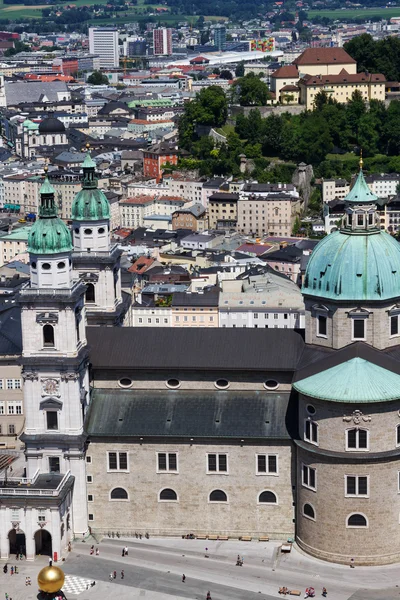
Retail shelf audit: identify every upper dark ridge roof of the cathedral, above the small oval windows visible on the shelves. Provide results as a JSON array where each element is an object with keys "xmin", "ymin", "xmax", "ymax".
[{"xmin": 86, "ymin": 327, "xmax": 304, "ymax": 371}]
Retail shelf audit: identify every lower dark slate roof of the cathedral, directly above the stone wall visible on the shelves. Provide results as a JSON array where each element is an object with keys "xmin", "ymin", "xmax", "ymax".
[{"xmin": 85, "ymin": 389, "xmax": 289, "ymax": 439}]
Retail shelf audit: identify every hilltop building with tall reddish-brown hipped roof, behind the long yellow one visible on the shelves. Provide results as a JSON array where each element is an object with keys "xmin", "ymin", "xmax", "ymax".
[{"xmin": 293, "ymin": 48, "xmax": 357, "ymax": 77}]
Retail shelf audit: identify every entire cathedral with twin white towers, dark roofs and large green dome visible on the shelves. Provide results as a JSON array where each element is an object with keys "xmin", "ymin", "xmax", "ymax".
[{"xmin": 0, "ymin": 154, "xmax": 400, "ymax": 565}]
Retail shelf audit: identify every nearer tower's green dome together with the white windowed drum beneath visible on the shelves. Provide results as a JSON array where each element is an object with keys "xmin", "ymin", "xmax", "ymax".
[{"xmin": 28, "ymin": 172, "xmax": 72, "ymax": 287}]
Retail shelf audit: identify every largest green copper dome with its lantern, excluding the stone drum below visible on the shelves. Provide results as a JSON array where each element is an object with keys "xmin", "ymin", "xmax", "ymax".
[{"xmin": 302, "ymin": 163, "xmax": 400, "ymax": 301}]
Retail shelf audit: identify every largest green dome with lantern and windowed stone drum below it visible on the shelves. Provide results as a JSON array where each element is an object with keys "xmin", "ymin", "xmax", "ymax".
[{"xmin": 302, "ymin": 159, "xmax": 400, "ymax": 348}]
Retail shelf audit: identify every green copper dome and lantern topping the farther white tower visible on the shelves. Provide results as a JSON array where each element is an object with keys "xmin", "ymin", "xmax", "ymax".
[{"xmin": 72, "ymin": 152, "xmax": 110, "ymax": 221}]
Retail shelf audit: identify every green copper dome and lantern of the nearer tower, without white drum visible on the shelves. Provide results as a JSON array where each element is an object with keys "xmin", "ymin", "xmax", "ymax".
[{"xmin": 28, "ymin": 176, "xmax": 72, "ymax": 254}]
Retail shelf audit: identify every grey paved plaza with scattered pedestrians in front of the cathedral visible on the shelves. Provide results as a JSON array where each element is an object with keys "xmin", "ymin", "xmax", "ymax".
[{"xmin": 0, "ymin": 537, "xmax": 400, "ymax": 600}]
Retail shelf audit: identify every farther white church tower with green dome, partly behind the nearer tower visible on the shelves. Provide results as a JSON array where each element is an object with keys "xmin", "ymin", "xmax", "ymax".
[{"xmin": 72, "ymin": 152, "xmax": 124, "ymax": 326}]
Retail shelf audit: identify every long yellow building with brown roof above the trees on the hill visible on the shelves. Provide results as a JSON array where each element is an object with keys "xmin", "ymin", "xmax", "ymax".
[{"xmin": 298, "ymin": 70, "xmax": 385, "ymax": 110}]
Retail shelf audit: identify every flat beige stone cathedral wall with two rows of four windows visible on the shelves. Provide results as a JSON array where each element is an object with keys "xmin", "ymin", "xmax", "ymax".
[{"xmin": 87, "ymin": 440, "xmax": 295, "ymax": 539}]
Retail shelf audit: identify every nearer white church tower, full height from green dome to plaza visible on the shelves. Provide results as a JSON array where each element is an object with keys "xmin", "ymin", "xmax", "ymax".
[{"xmin": 15, "ymin": 171, "xmax": 89, "ymax": 560}]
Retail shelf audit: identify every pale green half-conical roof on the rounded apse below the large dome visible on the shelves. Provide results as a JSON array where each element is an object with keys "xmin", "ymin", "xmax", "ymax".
[{"xmin": 293, "ymin": 356, "xmax": 400, "ymax": 403}]
